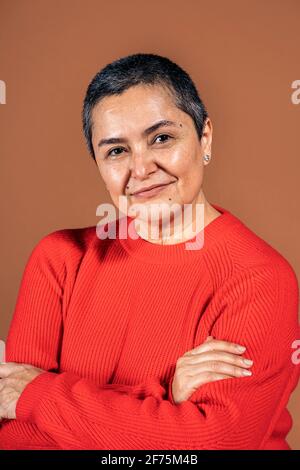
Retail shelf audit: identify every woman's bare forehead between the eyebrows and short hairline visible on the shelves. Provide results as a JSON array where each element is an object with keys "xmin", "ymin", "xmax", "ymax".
[{"xmin": 92, "ymin": 85, "xmax": 186, "ymax": 137}]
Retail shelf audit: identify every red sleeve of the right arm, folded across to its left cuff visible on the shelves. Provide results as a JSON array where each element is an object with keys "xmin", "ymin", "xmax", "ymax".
[{"xmin": 12, "ymin": 262, "xmax": 299, "ymax": 450}]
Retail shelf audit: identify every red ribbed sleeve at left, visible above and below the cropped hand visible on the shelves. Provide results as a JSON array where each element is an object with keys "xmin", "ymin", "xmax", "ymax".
[{"xmin": 0, "ymin": 229, "xmax": 80, "ymax": 449}]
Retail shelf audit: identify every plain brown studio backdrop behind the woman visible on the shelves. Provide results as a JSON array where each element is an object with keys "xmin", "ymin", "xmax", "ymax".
[{"xmin": 0, "ymin": 0, "xmax": 300, "ymax": 449}]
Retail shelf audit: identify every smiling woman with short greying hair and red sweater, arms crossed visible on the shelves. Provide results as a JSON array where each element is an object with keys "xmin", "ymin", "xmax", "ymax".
[{"xmin": 0, "ymin": 54, "xmax": 299, "ymax": 449}]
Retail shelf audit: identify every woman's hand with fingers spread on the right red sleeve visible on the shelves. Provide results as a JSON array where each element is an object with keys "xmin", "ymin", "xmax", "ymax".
[{"xmin": 172, "ymin": 336, "xmax": 253, "ymax": 404}]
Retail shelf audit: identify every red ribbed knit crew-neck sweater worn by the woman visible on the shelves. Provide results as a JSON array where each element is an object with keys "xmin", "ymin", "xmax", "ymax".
[{"xmin": 0, "ymin": 204, "xmax": 300, "ymax": 450}]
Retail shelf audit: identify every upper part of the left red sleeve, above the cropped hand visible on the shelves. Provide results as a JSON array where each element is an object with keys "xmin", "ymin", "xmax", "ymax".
[{"xmin": 6, "ymin": 231, "xmax": 66, "ymax": 370}]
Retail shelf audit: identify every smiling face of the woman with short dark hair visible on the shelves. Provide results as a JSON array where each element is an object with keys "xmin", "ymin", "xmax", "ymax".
[{"xmin": 92, "ymin": 85, "xmax": 212, "ymax": 222}]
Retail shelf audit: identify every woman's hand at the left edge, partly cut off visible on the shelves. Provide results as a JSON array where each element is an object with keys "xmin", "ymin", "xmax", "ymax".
[{"xmin": 0, "ymin": 362, "xmax": 45, "ymax": 419}]
